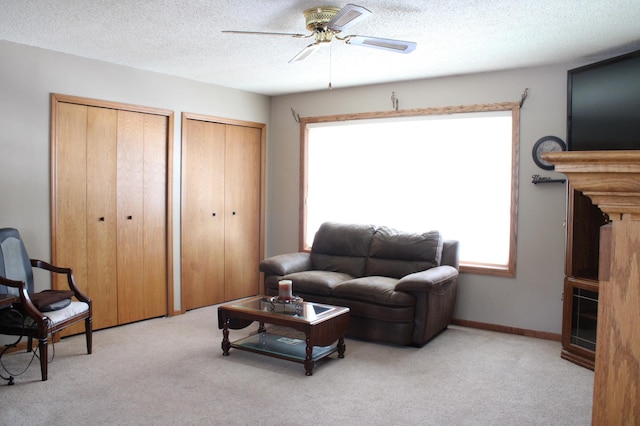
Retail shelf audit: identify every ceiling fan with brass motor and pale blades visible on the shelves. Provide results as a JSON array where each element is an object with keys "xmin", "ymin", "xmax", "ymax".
[{"xmin": 222, "ymin": 4, "xmax": 417, "ymax": 63}]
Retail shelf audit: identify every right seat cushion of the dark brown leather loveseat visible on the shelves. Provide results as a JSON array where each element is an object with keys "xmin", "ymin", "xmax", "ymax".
[{"xmin": 333, "ymin": 276, "xmax": 416, "ymax": 307}]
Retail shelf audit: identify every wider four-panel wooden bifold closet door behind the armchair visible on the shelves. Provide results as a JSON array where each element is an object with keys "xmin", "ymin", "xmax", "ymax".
[{"xmin": 52, "ymin": 95, "xmax": 172, "ymax": 329}]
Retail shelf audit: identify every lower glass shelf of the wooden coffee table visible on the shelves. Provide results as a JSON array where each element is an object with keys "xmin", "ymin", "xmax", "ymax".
[{"xmin": 231, "ymin": 332, "xmax": 338, "ymax": 362}]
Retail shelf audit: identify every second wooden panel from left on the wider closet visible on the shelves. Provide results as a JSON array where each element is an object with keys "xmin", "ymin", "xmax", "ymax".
[{"xmin": 81, "ymin": 107, "xmax": 118, "ymax": 329}]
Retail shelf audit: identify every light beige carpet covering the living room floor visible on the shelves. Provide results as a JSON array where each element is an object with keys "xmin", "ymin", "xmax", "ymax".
[{"xmin": 0, "ymin": 306, "xmax": 593, "ymax": 426}]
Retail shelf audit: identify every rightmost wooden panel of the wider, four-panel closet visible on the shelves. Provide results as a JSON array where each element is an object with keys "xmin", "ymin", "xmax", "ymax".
[{"xmin": 143, "ymin": 114, "xmax": 168, "ymax": 318}]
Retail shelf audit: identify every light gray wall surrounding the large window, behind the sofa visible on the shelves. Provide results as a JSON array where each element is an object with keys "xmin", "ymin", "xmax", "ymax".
[{"xmin": 266, "ymin": 66, "xmax": 584, "ymax": 333}]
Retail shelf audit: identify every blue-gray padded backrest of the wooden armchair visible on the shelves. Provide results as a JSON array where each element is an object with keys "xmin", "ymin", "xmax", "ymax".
[{"xmin": 0, "ymin": 228, "xmax": 34, "ymax": 296}]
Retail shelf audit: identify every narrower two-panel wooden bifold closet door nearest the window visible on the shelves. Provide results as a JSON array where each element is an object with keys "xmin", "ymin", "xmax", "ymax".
[{"xmin": 181, "ymin": 114, "xmax": 265, "ymax": 310}]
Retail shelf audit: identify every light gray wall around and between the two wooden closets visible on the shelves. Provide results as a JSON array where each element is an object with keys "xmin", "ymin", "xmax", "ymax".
[{"xmin": 0, "ymin": 40, "xmax": 271, "ymax": 310}]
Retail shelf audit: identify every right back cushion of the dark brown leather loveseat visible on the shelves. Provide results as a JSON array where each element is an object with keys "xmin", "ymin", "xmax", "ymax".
[{"xmin": 365, "ymin": 226, "xmax": 443, "ymax": 278}]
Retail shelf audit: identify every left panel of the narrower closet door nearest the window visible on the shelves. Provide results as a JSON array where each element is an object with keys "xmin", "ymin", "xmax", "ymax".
[{"xmin": 182, "ymin": 119, "xmax": 225, "ymax": 310}]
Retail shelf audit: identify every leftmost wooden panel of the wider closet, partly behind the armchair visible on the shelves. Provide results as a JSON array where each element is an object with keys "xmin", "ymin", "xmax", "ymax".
[{"xmin": 52, "ymin": 103, "xmax": 89, "ymax": 290}]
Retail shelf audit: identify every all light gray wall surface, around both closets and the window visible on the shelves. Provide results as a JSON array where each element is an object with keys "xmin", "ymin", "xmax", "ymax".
[{"xmin": 0, "ymin": 37, "xmax": 584, "ymax": 333}]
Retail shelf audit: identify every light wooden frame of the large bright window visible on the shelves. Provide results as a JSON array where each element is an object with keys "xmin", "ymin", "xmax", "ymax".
[{"xmin": 299, "ymin": 102, "xmax": 520, "ymax": 277}]
